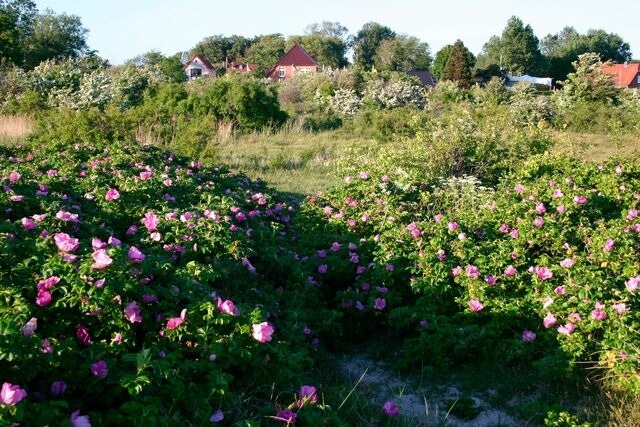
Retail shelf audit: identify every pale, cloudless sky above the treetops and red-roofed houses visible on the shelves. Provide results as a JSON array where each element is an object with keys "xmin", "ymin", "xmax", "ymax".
[{"xmin": 35, "ymin": 0, "xmax": 640, "ymax": 65}]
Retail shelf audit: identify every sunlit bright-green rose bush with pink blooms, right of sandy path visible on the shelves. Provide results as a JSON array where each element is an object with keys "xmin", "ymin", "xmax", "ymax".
[{"xmin": 303, "ymin": 155, "xmax": 640, "ymax": 392}]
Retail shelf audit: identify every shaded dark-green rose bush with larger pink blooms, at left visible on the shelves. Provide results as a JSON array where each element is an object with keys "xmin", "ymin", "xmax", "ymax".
[{"xmin": 0, "ymin": 135, "xmax": 335, "ymax": 426}]
